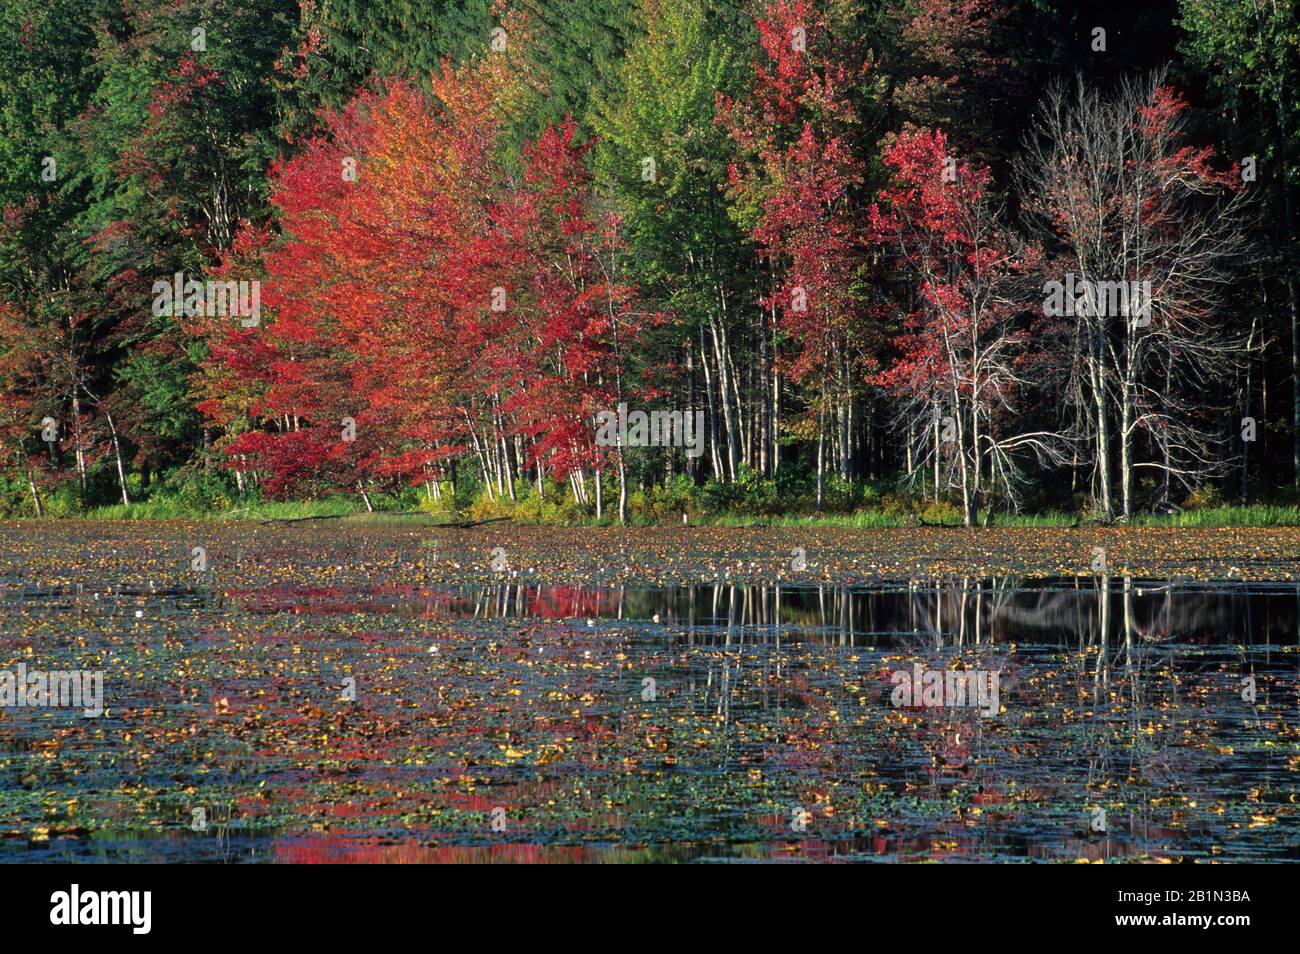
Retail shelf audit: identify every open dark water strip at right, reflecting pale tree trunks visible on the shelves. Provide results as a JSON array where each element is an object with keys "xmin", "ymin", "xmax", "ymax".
[{"xmin": 343, "ymin": 577, "xmax": 1300, "ymax": 646}]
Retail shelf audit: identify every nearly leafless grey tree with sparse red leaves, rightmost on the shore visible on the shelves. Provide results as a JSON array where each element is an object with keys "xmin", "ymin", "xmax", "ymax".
[{"xmin": 1018, "ymin": 73, "xmax": 1248, "ymax": 517}]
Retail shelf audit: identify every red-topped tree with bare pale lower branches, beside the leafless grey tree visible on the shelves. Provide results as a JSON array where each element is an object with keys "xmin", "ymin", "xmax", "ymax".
[{"xmin": 874, "ymin": 131, "xmax": 1065, "ymax": 526}]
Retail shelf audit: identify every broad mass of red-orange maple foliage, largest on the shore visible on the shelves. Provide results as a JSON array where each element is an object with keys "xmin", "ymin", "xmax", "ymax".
[{"xmin": 202, "ymin": 73, "xmax": 646, "ymax": 494}]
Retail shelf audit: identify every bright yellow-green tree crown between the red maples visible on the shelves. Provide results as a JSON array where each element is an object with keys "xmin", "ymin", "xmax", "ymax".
[{"xmin": 592, "ymin": 0, "xmax": 755, "ymax": 376}]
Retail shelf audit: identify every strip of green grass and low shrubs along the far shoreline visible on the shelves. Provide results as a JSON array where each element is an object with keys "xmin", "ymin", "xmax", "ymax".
[{"xmin": 10, "ymin": 468, "xmax": 1300, "ymax": 529}]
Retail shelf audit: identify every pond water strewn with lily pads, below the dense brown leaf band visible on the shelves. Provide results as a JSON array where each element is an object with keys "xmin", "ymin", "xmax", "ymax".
[{"xmin": 0, "ymin": 577, "xmax": 1300, "ymax": 862}]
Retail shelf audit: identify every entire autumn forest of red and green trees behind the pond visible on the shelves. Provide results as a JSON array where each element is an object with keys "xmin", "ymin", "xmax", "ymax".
[{"xmin": 0, "ymin": 0, "xmax": 1300, "ymax": 525}]
